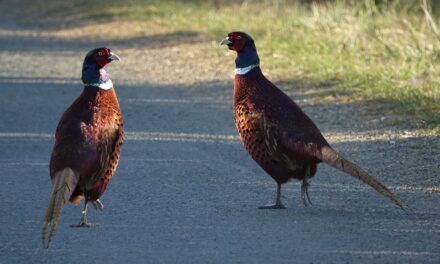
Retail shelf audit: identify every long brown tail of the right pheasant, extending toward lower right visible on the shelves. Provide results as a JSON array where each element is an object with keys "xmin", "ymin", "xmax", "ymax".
[{"xmin": 320, "ymin": 147, "xmax": 414, "ymax": 215}]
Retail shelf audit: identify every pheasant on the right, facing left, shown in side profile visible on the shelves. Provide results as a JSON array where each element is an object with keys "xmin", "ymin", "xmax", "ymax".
[{"xmin": 220, "ymin": 32, "xmax": 412, "ymax": 213}]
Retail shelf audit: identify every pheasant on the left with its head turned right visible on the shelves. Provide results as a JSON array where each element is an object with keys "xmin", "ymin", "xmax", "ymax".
[{"xmin": 42, "ymin": 48, "xmax": 124, "ymax": 248}]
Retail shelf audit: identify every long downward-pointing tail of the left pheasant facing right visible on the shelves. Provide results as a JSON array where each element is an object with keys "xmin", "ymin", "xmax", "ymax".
[{"xmin": 41, "ymin": 168, "xmax": 78, "ymax": 248}]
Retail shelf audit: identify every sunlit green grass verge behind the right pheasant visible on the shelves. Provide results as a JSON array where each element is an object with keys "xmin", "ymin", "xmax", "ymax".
[{"xmin": 31, "ymin": 0, "xmax": 440, "ymax": 134}]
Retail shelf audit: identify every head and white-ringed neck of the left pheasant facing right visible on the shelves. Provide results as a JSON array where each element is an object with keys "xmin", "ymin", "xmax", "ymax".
[{"xmin": 81, "ymin": 48, "xmax": 120, "ymax": 89}]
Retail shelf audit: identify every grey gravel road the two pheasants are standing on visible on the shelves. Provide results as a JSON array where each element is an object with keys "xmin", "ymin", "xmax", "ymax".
[{"xmin": 0, "ymin": 9, "xmax": 440, "ymax": 264}]
